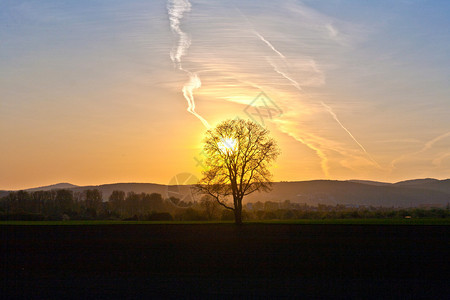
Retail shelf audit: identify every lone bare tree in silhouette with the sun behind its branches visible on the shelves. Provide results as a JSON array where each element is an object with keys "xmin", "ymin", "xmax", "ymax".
[{"xmin": 197, "ymin": 120, "xmax": 280, "ymax": 224}]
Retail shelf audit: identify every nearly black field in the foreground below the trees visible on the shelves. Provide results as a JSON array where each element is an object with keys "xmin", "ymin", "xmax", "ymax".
[{"xmin": 0, "ymin": 224, "xmax": 450, "ymax": 299}]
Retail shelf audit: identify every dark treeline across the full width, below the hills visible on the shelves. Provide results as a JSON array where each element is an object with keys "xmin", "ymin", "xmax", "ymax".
[{"xmin": 0, "ymin": 189, "xmax": 450, "ymax": 221}]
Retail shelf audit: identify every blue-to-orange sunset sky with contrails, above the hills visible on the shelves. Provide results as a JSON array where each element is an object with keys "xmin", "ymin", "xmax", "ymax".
[{"xmin": 0, "ymin": 0, "xmax": 450, "ymax": 189}]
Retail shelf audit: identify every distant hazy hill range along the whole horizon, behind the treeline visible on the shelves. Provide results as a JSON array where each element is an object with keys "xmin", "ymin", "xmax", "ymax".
[{"xmin": 0, "ymin": 178, "xmax": 450, "ymax": 207}]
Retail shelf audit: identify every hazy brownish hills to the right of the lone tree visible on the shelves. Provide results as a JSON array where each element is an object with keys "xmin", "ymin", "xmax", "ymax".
[{"xmin": 247, "ymin": 180, "xmax": 450, "ymax": 207}]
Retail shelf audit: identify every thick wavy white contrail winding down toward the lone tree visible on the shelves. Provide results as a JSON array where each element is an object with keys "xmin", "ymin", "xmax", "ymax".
[{"xmin": 167, "ymin": 0, "xmax": 210, "ymax": 128}]
